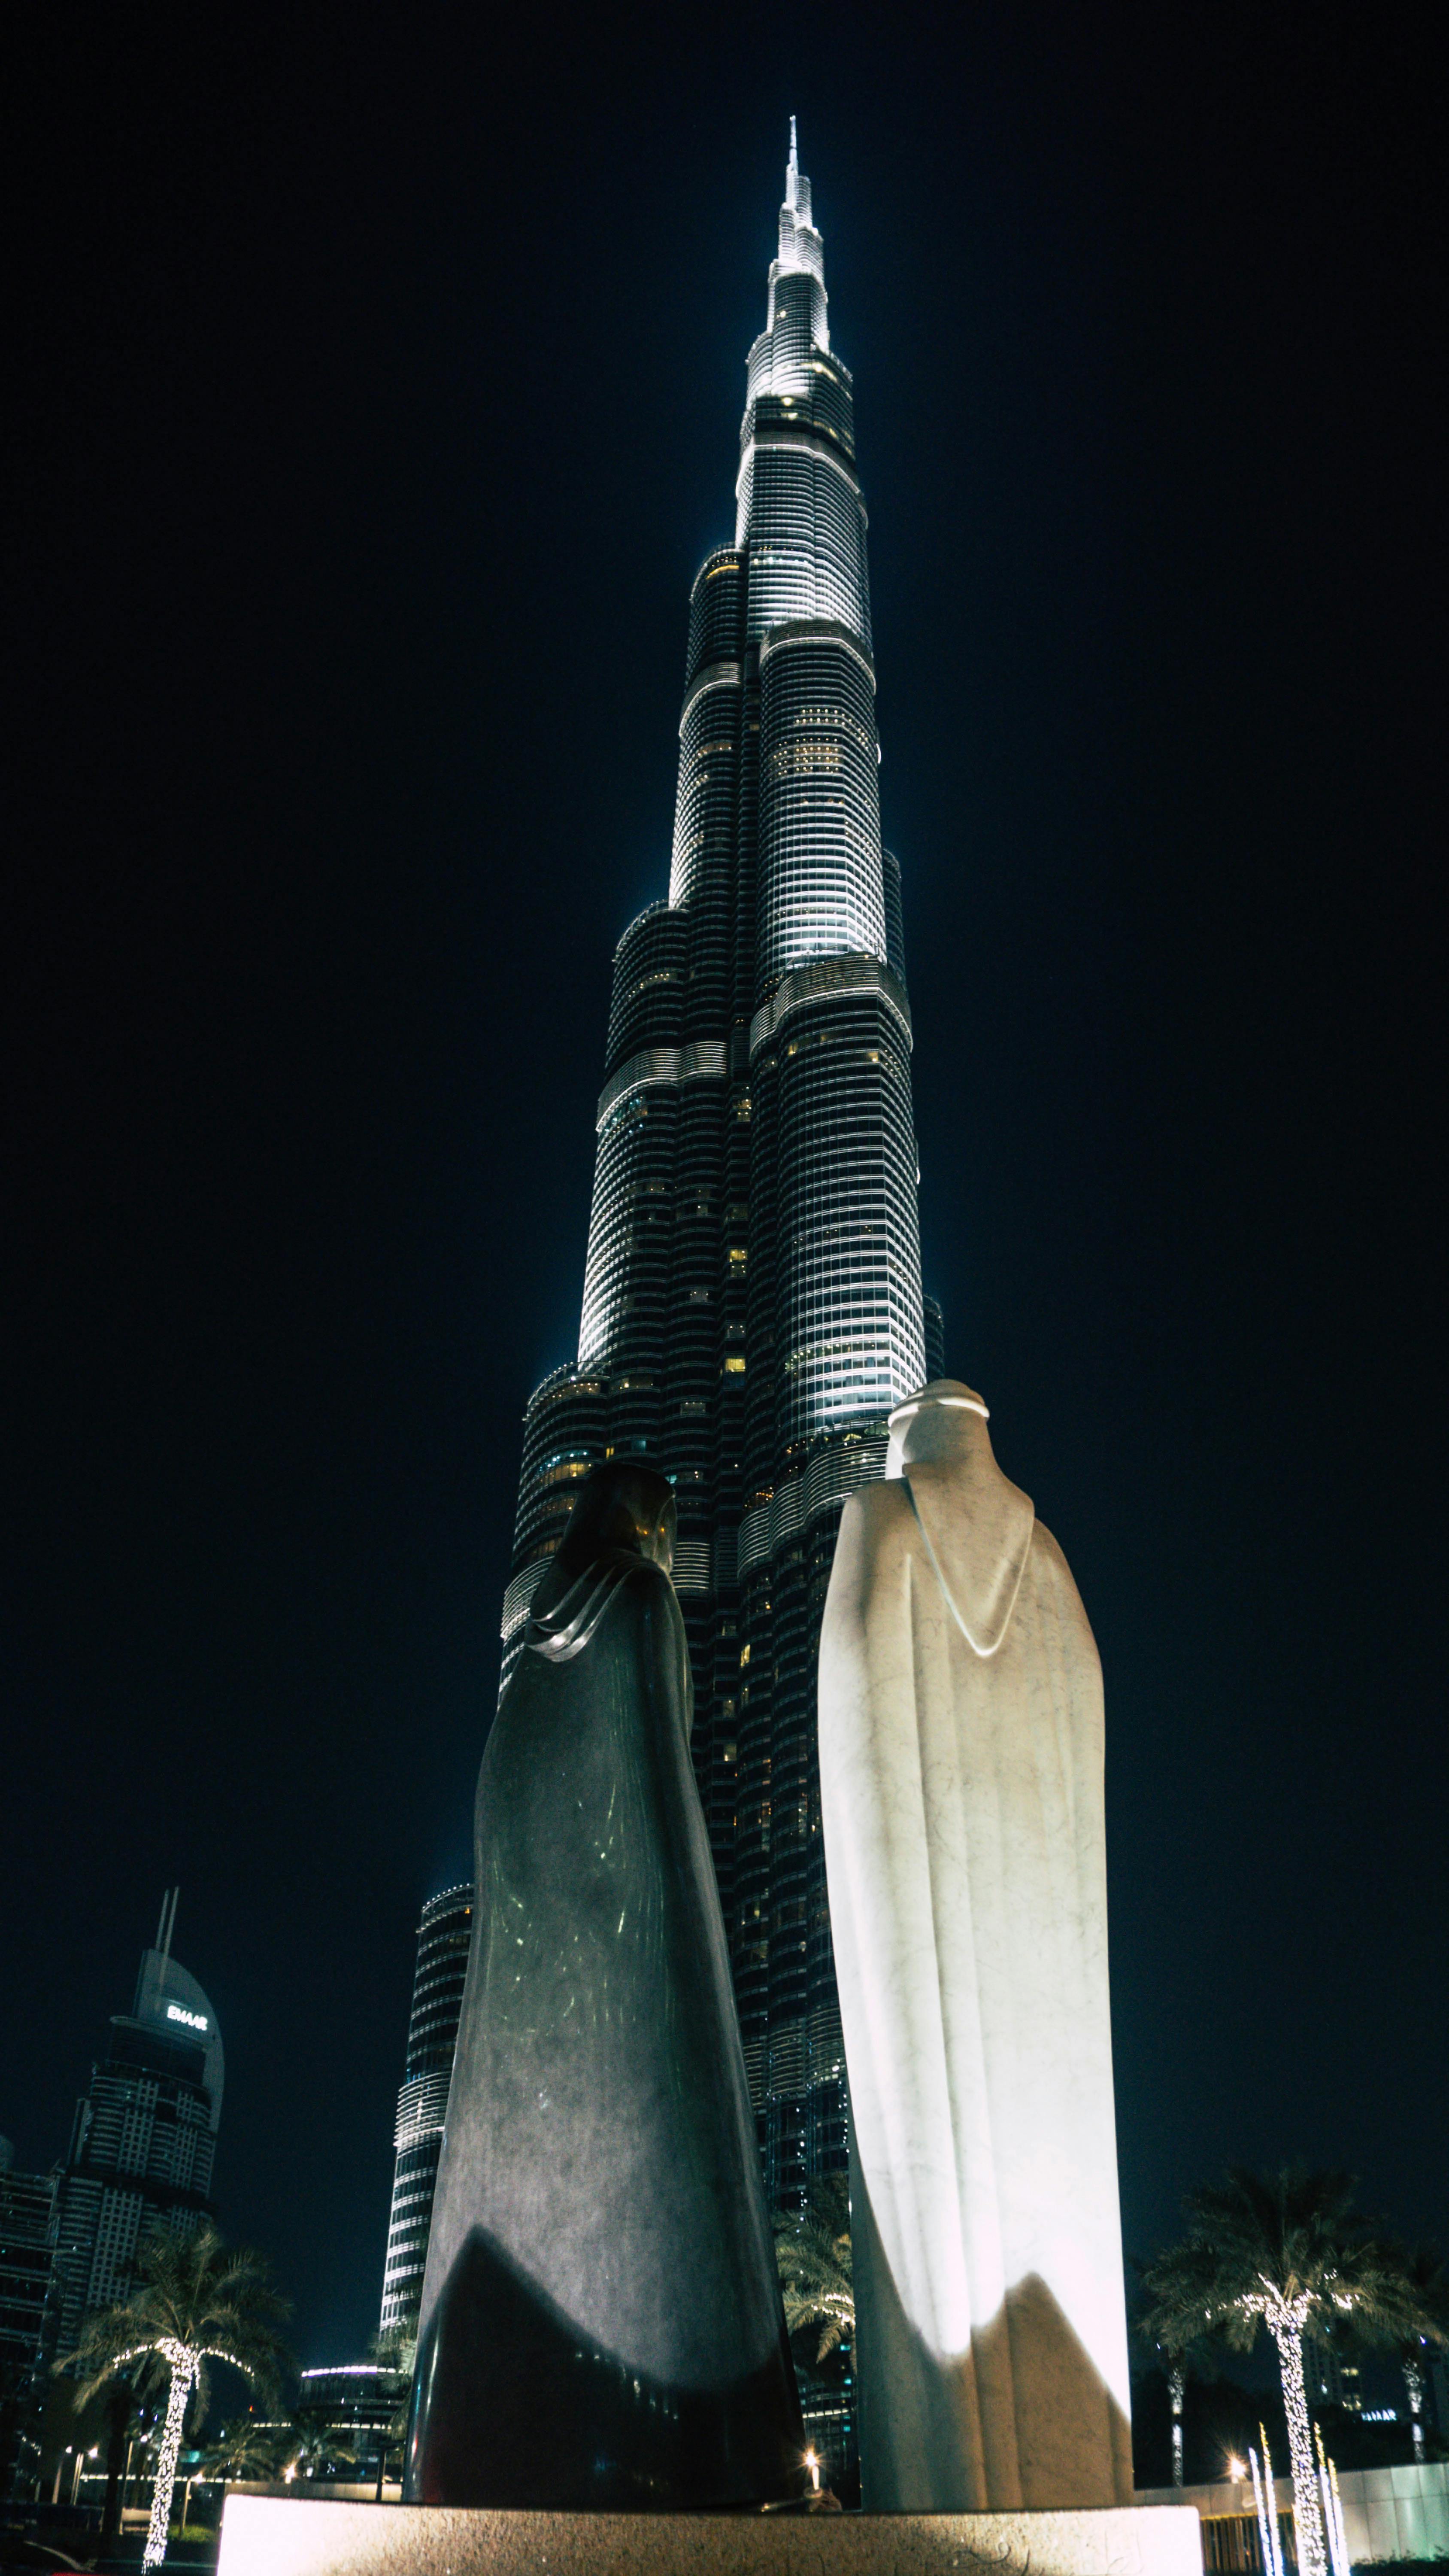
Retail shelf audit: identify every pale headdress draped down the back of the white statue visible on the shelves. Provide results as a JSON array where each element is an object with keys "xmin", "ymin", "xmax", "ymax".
[{"xmin": 901, "ymin": 1406, "xmax": 1037, "ymax": 1656}]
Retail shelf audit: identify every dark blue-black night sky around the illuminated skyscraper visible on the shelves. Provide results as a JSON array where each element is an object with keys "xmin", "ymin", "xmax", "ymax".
[{"xmin": 0, "ymin": 5, "xmax": 1449, "ymax": 2362}]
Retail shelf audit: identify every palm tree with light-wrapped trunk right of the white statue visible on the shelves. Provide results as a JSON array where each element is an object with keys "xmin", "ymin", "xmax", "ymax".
[{"xmin": 1143, "ymin": 2164, "xmax": 1441, "ymax": 2576}]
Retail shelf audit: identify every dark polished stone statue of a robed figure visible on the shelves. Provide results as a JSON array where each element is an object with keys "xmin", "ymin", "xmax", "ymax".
[{"xmin": 404, "ymin": 1461, "xmax": 806, "ymax": 2512}]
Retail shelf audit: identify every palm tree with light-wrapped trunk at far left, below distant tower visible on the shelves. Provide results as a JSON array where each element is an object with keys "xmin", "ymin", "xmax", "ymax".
[{"xmin": 57, "ymin": 2221, "xmax": 286, "ymax": 2568}]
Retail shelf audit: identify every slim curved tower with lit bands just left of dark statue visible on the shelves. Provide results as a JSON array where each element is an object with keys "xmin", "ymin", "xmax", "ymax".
[{"xmin": 378, "ymin": 1886, "xmax": 473, "ymax": 2334}]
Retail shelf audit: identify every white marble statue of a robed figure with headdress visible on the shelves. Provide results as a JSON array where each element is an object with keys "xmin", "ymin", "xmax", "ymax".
[{"xmin": 821, "ymin": 1378, "xmax": 1132, "ymax": 2512}]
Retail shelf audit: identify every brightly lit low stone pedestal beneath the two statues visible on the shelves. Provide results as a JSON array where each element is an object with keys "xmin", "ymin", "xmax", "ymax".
[{"xmin": 219, "ymin": 2496, "xmax": 1202, "ymax": 2576}]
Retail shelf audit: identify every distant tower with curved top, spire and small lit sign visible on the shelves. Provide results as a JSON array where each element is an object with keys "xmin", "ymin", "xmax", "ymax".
[{"xmin": 57, "ymin": 1888, "xmax": 227, "ymax": 2352}]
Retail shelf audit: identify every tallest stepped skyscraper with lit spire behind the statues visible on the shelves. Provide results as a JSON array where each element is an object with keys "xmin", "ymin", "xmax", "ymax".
[{"xmin": 502, "ymin": 129, "xmax": 942, "ymax": 2202}]
